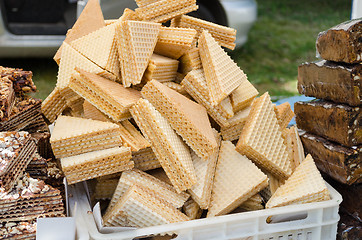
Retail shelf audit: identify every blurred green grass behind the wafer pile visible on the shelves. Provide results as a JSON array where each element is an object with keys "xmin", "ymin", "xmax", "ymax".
[{"xmin": 0, "ymin": 0, "xmax": 352, "ymax": 100}]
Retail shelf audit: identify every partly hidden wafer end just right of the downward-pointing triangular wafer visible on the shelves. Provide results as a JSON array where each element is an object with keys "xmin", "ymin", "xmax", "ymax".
[{"xmin": 142, "ymin": 53, "xmax": 178, "ymax": 82}]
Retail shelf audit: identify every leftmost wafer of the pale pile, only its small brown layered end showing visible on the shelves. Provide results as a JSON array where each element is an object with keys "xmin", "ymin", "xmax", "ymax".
[{"xmin": 41, "ymin": 87, "xmax": 67, "ymax": 123}]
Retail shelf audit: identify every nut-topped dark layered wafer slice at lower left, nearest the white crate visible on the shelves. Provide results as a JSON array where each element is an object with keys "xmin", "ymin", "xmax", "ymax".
[{"xmin": 0, "ymin": 173, "xmax": 65, "ymax": 222}]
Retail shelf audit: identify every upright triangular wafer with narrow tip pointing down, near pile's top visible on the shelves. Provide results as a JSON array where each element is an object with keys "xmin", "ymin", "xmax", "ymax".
[{"xmin": 116, "ymin": 20, "xmax": 161, "ymax": 87}]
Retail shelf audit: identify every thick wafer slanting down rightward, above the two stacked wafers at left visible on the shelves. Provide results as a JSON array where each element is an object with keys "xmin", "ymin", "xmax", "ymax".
[{"xmin": 69, "ymin": 69, "xmax": 141, "ymax": 122}]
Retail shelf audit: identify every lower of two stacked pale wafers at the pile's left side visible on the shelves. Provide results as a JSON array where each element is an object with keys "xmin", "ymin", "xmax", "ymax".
[{"xmin": 60, "ymin": 147, "xmax": 134, "ymax": 184}]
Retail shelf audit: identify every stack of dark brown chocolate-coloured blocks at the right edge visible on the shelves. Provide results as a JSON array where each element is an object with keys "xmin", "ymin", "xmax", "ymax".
[{"xmin": 294, "ymin": 19, "xmax": 362, "ymax": 239}]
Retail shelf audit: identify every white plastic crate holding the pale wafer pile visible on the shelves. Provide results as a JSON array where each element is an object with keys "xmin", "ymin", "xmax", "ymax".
[{"xmin": 68, "ymin": 183, "xmax": 342, "ymax": 240}]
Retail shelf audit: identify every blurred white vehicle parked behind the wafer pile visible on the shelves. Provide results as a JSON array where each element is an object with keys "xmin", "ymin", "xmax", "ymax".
[{"xmin": 0, "ymin": 0, "xmax": 257, "ymax": 58}]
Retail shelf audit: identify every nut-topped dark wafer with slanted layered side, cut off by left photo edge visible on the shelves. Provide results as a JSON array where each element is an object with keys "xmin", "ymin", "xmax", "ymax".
[{"xmin": 0, "ymin": 131, "xmax": 36, "ymax": 192}]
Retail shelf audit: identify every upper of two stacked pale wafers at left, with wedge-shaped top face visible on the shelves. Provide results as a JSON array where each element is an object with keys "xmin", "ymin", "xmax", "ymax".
[{"xmin": 50, "ymin": 116, "xmax": 122, "ymax": 158}]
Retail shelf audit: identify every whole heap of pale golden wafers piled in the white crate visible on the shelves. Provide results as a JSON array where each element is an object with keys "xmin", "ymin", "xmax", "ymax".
[{"xmin": 42, "ymin": 0, "xmax": 329, "ymax": 230}]
